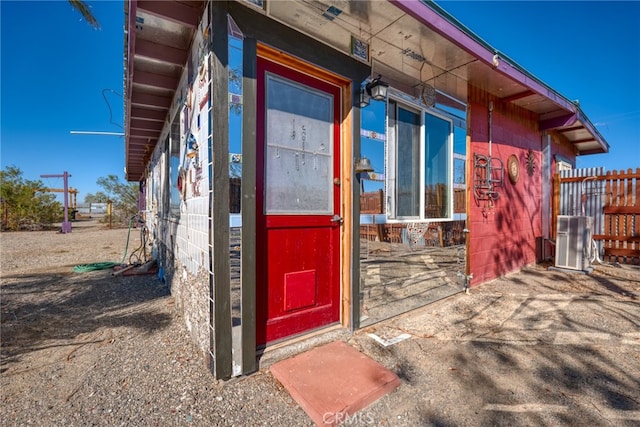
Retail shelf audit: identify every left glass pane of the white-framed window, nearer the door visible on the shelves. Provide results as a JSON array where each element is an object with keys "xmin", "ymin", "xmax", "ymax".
[{"xmin": 396, "ymin": 107, "xmax": 420, "ymax": 217}]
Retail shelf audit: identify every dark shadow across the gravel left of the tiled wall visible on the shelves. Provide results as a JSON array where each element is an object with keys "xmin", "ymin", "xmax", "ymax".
[{"xmin": 0, "ymin": 270, "xmax": 171, "ymax": 372}]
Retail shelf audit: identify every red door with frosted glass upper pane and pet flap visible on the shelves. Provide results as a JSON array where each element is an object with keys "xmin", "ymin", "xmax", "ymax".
[{"xmin": 256, "ymin": 58, "xmax": 341, "ymax": 345}]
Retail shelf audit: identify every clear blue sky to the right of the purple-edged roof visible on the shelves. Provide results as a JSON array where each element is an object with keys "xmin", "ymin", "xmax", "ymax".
[{"xmin": 437, "ymin": 1, "xmax": 640, "ymax": 170}]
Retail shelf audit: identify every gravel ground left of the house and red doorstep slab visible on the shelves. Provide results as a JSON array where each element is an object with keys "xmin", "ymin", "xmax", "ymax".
[{"xmin": 0, "ymin": 221, "xmax": 310, "ymax": 426}]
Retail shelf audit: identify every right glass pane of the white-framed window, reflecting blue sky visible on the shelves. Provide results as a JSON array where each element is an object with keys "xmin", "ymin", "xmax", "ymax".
[{"xmin": 424, "ymin": 114, "xmax": 451, "ymax": 218}]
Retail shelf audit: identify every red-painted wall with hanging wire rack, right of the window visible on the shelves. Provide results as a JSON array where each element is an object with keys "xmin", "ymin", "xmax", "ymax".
[{"xmin": 468, "ymin": 102, "xmax": 546, "ymax": 285}]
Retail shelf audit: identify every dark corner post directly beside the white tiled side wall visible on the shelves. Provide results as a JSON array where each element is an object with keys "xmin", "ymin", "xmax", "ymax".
[{"xmin": 209, "ymin": 1, "xmax": 232, "ymax": 379}]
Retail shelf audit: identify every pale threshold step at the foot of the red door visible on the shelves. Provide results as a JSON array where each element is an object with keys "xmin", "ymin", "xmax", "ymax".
[{"xmin": 256, "ymin": 323, "xmax": 351, "ymax": 369}]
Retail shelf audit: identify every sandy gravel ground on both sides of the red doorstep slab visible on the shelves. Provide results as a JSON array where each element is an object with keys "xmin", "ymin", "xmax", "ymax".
[{"xmin": 0, "ymin": 221, "xmax": 640, "ymax": 426}]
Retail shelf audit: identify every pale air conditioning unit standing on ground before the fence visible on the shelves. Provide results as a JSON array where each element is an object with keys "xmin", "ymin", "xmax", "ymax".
[{"xmin": 556, "ymin": 215, "xmax": 593, "ymax": 270}]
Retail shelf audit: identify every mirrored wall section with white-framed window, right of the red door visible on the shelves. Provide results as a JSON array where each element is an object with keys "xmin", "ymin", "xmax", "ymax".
[{"xmin": 359, "ymin": 88, "xmax": 466, "ymax": 327}]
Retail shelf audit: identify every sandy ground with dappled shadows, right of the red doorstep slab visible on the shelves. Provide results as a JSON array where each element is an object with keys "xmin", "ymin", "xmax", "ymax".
[{"xmin": 360, "ymin": 267, "xmax": 640, "ymax": 426}]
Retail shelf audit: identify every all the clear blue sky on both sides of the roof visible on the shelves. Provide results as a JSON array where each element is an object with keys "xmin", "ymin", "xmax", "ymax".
[{"xmin": 0, "ymin": 0, "xmax": 640, "ymax": 201}]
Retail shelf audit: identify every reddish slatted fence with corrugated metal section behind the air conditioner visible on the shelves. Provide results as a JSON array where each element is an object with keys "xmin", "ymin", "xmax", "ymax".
[{"xmin": 552, "ymin": 168, "xmax": 640, "ymax": 264}]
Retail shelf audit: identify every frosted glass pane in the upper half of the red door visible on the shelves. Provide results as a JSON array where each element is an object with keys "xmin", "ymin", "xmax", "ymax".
[{"xmin": 265, "ymin": 75, "xmax": 333, "ymax": 215}]
